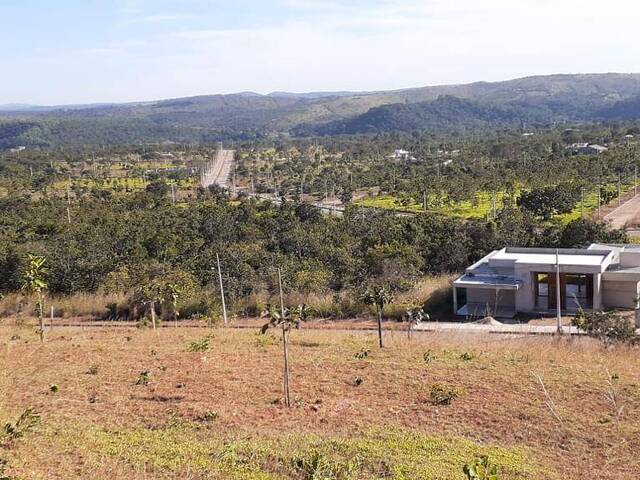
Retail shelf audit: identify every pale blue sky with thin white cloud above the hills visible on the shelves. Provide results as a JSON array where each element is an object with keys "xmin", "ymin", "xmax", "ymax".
[{"xmin": 0, "ymin": 0, "xmax": 640, "ymax": 105}]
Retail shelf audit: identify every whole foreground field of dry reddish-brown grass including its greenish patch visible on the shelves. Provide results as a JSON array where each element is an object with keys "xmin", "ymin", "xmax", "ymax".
[{"xmin": 0, "ymin": 323, "xmax": 640, "ymax": 480}]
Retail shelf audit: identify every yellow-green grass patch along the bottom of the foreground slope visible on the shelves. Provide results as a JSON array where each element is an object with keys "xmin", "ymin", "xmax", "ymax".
[{"xmin": 51, "ymin": 423, "xmax": 550, "ymax": 480}]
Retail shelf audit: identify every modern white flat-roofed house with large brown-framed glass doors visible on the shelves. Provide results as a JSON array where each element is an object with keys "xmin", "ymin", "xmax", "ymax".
[{"xmin": 453, "ymin": 244, "xmax": 640, "ymax": 318}]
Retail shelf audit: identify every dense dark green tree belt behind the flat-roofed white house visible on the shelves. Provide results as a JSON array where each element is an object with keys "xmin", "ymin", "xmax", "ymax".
[{"xmin": 0, "ymin": 188, "xmax": 624, "ymax": 298}]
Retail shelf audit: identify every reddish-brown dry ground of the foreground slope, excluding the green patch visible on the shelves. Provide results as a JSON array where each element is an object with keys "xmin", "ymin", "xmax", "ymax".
[{"xmin": 0, "ymin": 324, "xmax": 640, "ymax": 479}]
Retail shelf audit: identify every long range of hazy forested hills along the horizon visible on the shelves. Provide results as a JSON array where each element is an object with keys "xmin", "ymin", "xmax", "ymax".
[{"xmin": 0, "ymin": 73, "xmax": 640, "ymax": 148}]
